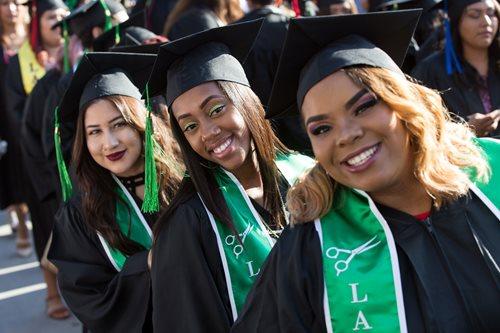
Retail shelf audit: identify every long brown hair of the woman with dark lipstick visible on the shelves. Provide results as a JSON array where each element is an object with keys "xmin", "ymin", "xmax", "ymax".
[{"xmin": 72, "ymin": 95, "xmax": 183, "ymax": 255}]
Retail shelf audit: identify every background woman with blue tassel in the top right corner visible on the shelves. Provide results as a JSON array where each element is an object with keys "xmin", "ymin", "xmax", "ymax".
[{"xmin": 412, "ymin": 0, "xmax": 500, "ymax": 136}]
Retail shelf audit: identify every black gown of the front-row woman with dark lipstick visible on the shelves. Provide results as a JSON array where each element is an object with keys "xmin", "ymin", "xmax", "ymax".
[{"xmin": 48, "ymin": 192, "xmax": 152, "ymax": 333}]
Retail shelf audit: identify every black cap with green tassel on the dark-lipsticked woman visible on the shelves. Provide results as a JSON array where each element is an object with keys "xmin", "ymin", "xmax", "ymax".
[{"xmin": 54, "ymin": 52, "xmax": 158, "ymax": 208}]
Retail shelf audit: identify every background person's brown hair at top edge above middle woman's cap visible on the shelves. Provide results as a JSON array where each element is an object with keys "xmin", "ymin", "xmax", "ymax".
[{"xmin": 163, "ymin": 0, "xmax": 243, "ymax": 37}]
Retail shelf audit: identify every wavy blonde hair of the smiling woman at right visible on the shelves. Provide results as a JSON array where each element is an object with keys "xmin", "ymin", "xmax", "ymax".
[{"xmin": 287, "ymin": 67, "xmax": 489, "ymax": 223}]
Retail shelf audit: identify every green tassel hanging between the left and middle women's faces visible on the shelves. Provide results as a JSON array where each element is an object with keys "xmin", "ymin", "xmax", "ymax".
[{"xmin": 141, "ymin": 84, "xmax": 160, "ymax": 213}]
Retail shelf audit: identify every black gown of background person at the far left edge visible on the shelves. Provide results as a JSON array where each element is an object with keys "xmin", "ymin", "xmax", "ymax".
[{"xmin": 4, "ymin": 55, "xmax": 29, "ymax": 204}]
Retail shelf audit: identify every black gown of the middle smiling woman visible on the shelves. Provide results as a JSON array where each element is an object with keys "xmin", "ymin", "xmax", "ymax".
[{"xmin": 151, "ymin": 179, "xmax": 288, "ymax": 333}]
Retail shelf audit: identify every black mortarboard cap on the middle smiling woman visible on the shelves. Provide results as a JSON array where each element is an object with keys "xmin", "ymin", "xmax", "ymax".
[{"xmin": 148, "ymin": 19, "xmax": 263, "ymax": 106}]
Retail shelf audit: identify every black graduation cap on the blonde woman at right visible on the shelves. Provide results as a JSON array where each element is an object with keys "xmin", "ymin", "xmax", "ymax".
[{"xmin": 266, "ymin": 9, "xmax": 421, "ymax": 118}]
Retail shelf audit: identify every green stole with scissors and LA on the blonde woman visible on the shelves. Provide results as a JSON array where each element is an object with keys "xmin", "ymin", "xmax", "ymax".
[{"xmin": 314, "ymin": 139, "xmax": 500, "ymax": 333}]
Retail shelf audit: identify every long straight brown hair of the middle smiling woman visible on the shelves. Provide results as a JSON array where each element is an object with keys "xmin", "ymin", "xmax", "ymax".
[{"xmin": 156, "ymin": 81, "xmax": 288, "ymax": 234}]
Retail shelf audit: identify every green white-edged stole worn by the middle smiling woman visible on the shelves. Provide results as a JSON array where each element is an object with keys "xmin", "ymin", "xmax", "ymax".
[{"xmin": 200, "ymin": 154, "xmax": 314, "ymax": 320}]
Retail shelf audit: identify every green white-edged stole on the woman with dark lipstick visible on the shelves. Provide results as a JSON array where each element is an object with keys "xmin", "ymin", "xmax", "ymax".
[{"xmin": 97, "ymin": 175, "xmax": 153, "ymax": 271}]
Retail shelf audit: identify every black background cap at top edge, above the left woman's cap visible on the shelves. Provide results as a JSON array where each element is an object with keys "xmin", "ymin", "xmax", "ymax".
[{"xmin": 54, "ymin": 0, "xmax": 126, "ymax": 37}]
